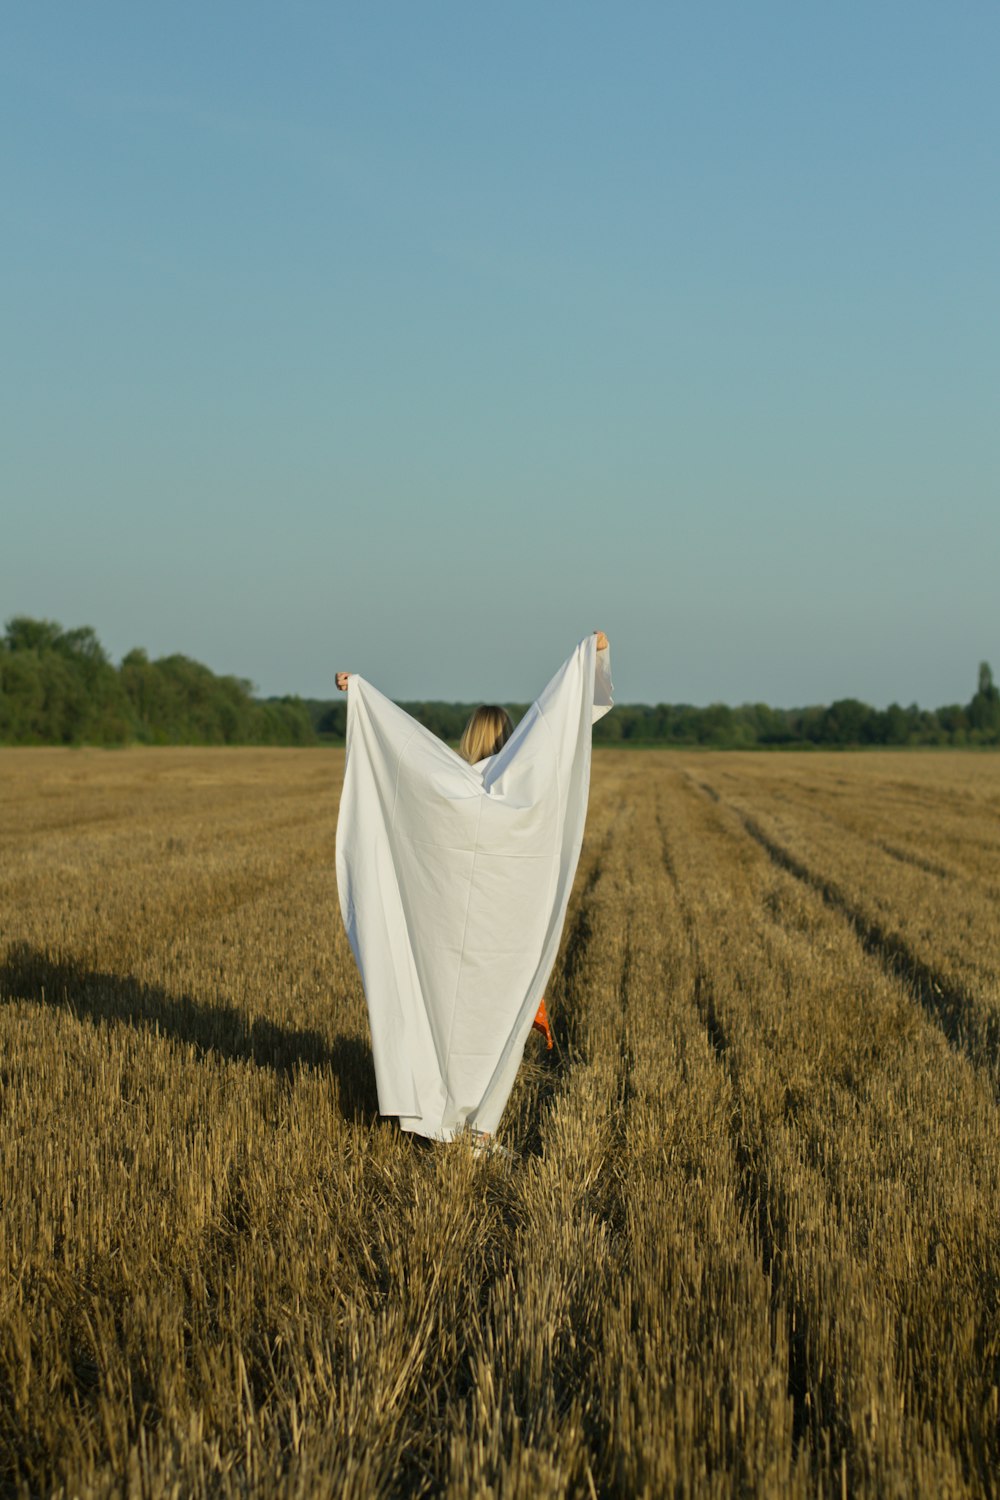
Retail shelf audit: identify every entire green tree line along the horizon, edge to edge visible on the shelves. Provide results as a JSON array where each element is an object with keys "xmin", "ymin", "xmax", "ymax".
[{"xmin": 0, "ymin": 615, "xmax": 1000, "ymax": 750}]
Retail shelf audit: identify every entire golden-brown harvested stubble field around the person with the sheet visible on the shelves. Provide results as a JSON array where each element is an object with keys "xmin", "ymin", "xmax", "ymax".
[{"xmin": 0, "ymin": 750, "xmax": 1000, "ymax": 1500}]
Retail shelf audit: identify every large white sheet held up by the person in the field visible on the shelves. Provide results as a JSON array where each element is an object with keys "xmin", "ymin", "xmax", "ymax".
[{"xmin": 337, "ymin": 635, "xmax": 612, "ymax": 1140}]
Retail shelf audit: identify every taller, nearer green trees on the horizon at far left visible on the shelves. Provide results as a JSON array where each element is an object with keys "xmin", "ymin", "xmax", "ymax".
[{"xmin": 0, "ymin": 615, "xmax": 315, "ymax": 746}]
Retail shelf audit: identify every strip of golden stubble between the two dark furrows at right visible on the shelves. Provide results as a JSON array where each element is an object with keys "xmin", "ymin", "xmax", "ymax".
[{"xmin": 659, "ymin": 782, "xmax": 1000, "ymax": 1494}]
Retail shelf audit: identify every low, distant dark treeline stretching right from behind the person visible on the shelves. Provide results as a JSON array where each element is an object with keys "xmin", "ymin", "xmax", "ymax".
[{"xmin": 304, "ymin": 662, "xmax": 1000, "ymax": 750}]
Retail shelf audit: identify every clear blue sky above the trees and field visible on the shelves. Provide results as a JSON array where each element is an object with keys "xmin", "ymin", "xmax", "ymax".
[{"xmin": 0, "ymin": 0, "xmax": 1000, "ymax": 707}]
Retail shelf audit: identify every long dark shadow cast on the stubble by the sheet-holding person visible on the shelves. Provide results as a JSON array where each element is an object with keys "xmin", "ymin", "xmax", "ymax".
[{"xmin": 0, "ymin": 944, "xmax": 378, "ymax": 1121}]
